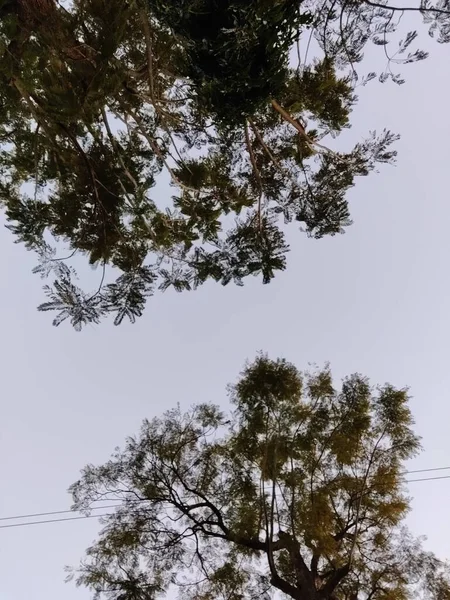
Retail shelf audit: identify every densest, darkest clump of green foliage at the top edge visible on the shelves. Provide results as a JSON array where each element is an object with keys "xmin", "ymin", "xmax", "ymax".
[{"xmin": 150, "ymin": 0, "xmax": 312, "ymax": 127}]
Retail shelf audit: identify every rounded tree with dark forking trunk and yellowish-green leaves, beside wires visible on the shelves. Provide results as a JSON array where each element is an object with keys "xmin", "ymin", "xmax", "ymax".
[{"xmin": 70, "ymin": 356, "xmax": 450, "ymax": 600}]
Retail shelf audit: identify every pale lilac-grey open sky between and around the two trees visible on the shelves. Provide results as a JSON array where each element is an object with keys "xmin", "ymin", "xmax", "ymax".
[{"xmin": 0, "ymin": 12, "xmax": 450, "ymax": 600}]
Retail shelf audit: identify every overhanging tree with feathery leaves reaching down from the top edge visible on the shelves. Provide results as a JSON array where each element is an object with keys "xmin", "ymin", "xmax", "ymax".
[{"xmin": 0, "ymin": 0, "xmax": 450, "ymax": 329}]
